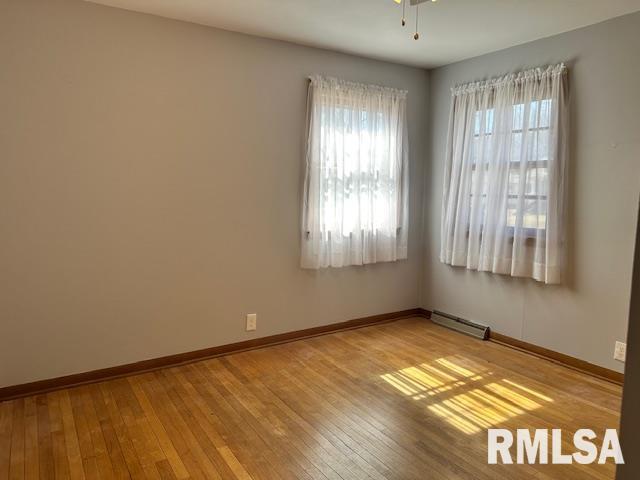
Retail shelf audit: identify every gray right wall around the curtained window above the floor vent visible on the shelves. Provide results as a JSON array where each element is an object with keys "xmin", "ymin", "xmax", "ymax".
[{"xmin": 421, "ymin": 13, "xmax": 640, "ymax": 371}]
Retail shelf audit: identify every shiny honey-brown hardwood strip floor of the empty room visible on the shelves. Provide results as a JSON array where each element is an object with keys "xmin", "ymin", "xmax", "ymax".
[{"xmin": 0, "ymin": 318, "xmax": 621, "ymax": 480}]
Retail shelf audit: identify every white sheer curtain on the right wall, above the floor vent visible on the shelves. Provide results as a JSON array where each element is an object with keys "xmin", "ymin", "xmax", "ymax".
[{"xmin": 440, "ymin": 64, "xmax": 568, "ymax": 283}]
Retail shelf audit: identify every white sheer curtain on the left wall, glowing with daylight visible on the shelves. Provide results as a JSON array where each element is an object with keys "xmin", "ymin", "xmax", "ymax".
[{"xmin": 301, "ymin": 76, "xmax": 409, "ymax": 268}]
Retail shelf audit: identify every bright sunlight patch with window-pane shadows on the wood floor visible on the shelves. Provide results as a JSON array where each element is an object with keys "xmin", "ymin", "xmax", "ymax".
[{"xmin": 380, "ymin": 357, "xmax": 553, "ymax": 435}]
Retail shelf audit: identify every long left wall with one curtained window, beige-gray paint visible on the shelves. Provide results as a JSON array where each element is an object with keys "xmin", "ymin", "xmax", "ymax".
[{"xmin": 0, "ymin": 0, "xmax": 428, "ymax": 386}]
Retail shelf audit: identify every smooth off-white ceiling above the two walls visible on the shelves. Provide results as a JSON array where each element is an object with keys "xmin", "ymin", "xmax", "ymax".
[{"xmin": 89, "ymin": 0, "xmax": 640, "ymax": 68}]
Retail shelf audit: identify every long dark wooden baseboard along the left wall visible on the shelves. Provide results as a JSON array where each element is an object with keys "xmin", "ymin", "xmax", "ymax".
[{"xmin": 0, "ymin": 308, "xmax": 430, "ymax": 402}]
